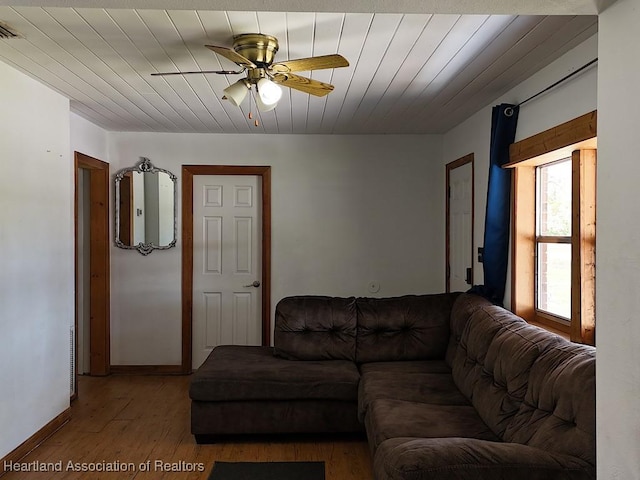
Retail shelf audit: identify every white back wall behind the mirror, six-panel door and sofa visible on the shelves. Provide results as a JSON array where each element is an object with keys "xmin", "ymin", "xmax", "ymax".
[{"xmin": 110, "ymin": 133, "xmax": 444, "ymax": 364}]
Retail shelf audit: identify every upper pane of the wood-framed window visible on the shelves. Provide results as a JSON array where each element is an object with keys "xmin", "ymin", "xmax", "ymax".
[{"xmin": 538, "ymin": 158, "xmax": 571, "ymax": 237}]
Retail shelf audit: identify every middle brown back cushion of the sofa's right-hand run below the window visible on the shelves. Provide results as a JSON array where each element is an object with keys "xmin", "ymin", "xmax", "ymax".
[{"xmin": 452, "ymin": 306, "xmax": 564, "ymax": 439}]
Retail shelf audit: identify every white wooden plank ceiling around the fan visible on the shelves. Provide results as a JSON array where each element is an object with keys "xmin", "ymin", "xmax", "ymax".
[{"xmin": 0, "ymin": 6, "xmax": 597, "ymax": 134}]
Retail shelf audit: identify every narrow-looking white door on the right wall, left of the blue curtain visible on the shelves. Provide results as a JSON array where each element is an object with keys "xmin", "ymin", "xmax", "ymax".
[{"xmin": 448, "ymin": 161, "xmax": 473, "ymax": 292}]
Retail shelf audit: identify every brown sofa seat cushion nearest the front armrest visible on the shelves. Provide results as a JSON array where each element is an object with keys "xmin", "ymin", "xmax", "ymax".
[{"xmin": 365, "ymin": 398, "xmax": 499, "ymax": 453}]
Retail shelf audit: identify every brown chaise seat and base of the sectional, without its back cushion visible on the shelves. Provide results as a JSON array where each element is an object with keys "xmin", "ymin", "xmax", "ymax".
[{"xmin": 189, "ymin": 345, "xmax": 362, "ymax": 443}]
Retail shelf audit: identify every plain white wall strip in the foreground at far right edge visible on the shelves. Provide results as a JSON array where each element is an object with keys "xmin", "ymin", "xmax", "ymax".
[{"xmin": 596, "ymin": 0, "xmax": 640, "ymax": 480}]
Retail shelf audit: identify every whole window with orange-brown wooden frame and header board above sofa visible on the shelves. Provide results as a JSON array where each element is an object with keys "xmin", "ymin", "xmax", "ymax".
[{"xmin": 508, "ymin": 112, "xmax": 597, "ymax": 345}]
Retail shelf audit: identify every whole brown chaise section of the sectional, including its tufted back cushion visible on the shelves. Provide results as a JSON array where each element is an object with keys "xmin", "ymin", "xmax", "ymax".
[{"xmin": 189, "ymin": 296, "xmax": 363, "ymax": 443}]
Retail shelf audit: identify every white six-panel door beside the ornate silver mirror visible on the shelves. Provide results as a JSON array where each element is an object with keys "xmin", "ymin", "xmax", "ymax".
[{"xmin": 192, "ymin": 175, "xmax": 262, "ymax": 368}]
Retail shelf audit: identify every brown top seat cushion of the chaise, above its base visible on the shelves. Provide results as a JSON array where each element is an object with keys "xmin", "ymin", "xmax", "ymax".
[{"xmin": 189, "ymin": 345, "xmax": 360, "ymax": 403}]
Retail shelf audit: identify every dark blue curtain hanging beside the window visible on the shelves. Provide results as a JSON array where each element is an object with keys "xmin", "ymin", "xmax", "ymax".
[{"xmin": 471, "ymin": 104, "xmax": 519, "ymax": 305}]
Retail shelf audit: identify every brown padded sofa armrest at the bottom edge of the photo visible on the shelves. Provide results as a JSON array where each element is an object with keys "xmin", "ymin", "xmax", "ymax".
[{"xmin": 373, "ymin": 438, "xmax": 596, "ymax": 480}]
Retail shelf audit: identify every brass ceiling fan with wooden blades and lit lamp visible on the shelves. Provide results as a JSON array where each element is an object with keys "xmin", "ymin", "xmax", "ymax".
[{"xmin": 151, "ymin": 33, "xmax": 349, "ymax": 116}]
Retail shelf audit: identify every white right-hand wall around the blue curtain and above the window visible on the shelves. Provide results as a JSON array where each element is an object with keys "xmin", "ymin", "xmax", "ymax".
[{"xmin": 440, "ymin": 35, "xmax": 598, "ymax": 306}]
